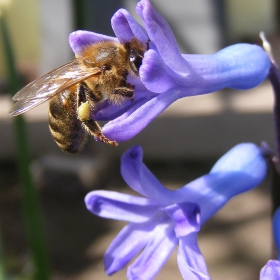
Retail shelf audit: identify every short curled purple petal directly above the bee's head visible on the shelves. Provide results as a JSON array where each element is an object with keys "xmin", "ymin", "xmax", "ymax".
[{"xmin": 111, "ymin": 9, "xmax": 148, "ymax": 45}]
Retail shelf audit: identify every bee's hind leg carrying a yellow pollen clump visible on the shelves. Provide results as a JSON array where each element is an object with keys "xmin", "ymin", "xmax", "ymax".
[{"xmin": 77, "ymin": 84, "xmax": 118, "ymax": 147}]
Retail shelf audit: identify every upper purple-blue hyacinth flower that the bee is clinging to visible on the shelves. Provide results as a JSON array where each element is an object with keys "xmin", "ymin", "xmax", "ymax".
[{"xmin": 69, "ymin": 0, "xmax": 270, "ymax": 142}]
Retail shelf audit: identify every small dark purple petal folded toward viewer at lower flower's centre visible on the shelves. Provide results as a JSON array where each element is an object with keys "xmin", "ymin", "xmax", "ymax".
[{"xmin": 164, "ymin": 202, "xmax": 200, "ymax": 238}]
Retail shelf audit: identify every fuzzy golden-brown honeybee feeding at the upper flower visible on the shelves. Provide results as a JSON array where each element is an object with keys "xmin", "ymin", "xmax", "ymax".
[{"xmin": 8, "ymin": 38, "xmax": 147, "ymax": 153}]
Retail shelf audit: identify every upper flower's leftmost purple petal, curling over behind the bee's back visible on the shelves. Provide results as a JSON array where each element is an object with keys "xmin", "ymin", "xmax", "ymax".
[{"xmin": 69, "ymin": 30, "xmax": 118, "ymax": 54}]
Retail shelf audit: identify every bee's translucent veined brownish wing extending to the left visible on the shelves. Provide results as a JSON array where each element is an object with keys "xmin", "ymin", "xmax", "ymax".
[{"xmin": 8, "ymin": 59, "xmax": 101, "ymax": 117}]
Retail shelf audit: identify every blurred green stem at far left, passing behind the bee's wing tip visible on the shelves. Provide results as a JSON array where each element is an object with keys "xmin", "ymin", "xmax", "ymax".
[{"xmin": 0, "ymin": 16, "xmax": 50, "ymax": 280}]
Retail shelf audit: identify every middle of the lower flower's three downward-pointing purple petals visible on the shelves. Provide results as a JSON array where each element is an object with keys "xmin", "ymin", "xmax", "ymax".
[{"xmin": 127, "ymin": 224, "xmax": 178, "ymax": 280}]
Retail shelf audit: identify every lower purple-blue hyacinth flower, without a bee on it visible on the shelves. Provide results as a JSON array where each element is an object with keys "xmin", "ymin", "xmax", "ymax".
[{"xmin": 85, "ymin": 143, "xmax": 267, "ymax": 280}]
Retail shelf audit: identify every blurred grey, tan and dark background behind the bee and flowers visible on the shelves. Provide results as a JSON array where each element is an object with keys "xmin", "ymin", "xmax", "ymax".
[{"xmin": 0, "ymin": 0, "xmax": 280, "ymax": 280}]
